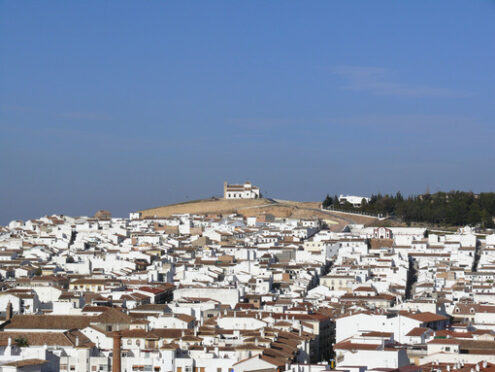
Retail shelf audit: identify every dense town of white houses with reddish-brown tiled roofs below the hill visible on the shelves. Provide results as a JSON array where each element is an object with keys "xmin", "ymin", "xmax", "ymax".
[{"xmin": 0, "ymin": 213, "xmax": 495, "ymax": 372}]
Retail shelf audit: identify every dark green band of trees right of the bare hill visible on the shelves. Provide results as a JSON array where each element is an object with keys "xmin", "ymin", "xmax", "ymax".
[{"xmin": 323, "ymin": 191, "xmax": 495, "ymax": 228}]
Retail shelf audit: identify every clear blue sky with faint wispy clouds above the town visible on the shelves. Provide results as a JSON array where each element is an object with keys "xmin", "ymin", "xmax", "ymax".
[{"xmin": 0, "ymin": 0, "xmax": 495, "ymax": 224}]
